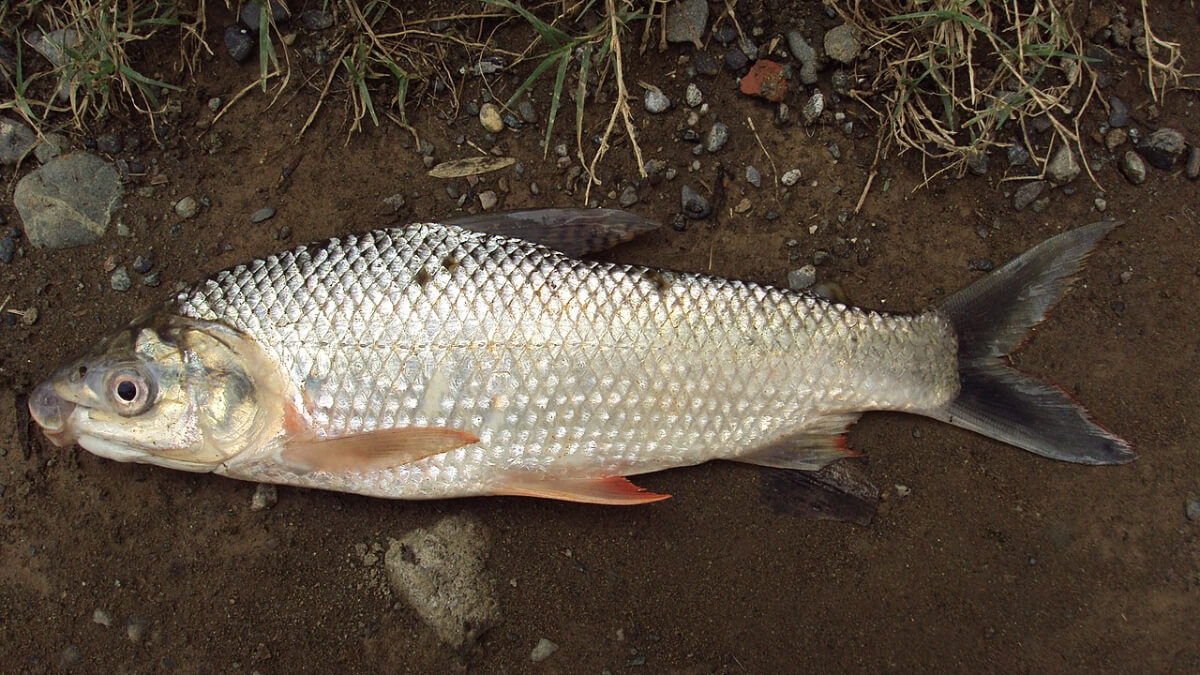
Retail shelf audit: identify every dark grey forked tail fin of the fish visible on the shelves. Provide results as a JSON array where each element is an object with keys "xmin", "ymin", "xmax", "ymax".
[{"xmin": 930, "ymin": 222, "xmax": 1136, "ymax": 464}]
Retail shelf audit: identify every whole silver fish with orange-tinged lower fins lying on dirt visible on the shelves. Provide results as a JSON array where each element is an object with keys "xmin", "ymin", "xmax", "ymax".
[{"xmin": 29, "ymin": 209, "xmax": 1135, "ymax": 504}]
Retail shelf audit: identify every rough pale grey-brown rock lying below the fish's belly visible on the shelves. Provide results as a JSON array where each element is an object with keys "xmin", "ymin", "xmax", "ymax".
[{"xmin": 384, "ymin": 515, "xmax": 500, "ymax": 649}]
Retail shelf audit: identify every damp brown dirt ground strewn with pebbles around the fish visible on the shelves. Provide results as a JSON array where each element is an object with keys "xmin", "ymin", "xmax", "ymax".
[{"xmin": 0, "ymin": 1, "xmax": 1200, "ymax": 674}]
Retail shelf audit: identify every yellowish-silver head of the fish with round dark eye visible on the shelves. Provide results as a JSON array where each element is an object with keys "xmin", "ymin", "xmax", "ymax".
[{"xmin": 29, "ymin": 313, "xmax": 283, "ymax": 472}]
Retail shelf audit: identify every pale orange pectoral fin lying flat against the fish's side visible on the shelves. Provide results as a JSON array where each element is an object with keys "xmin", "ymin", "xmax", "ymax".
[{"xmin": 280, "ymin": 426, "xmax": 479, "ymax": 472}]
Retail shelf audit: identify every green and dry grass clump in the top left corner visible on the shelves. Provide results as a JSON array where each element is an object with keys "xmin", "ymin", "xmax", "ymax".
[{"xmin": 0, "ymin": 0, "xmax": 180, "ymax": 129}]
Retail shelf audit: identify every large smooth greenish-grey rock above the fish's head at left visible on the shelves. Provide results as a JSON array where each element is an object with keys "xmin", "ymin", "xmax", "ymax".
[{"xmin": 12, "ymin": 153, "xmax": 121, "ymax": 249}]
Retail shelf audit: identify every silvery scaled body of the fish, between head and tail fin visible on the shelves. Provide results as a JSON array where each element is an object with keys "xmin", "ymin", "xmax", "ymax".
[{"xmin": 178, "ymin": 223, "xmax": 958, "ymax": 497}]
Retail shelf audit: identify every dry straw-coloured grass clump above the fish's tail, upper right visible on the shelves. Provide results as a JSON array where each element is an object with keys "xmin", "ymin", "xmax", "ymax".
[{"xmin": 838, "ymin": 0, "xmax": 1096, "ymax": 179}]
